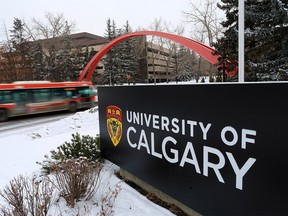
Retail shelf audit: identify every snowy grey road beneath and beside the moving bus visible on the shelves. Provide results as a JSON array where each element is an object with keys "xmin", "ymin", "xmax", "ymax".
[{"xmin": 0, "ymin": 112, "xmax": 74, "ymax": 137}]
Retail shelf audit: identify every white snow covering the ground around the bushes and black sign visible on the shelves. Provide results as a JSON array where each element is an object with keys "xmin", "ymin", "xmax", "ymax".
[{"xmin": 0, "ymin": 110, "xmax": 173, "ymax": 216}]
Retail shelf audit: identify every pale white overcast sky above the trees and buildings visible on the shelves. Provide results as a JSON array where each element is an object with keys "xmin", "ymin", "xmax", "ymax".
[{"xmin": 0, "ymin": 0, "xmax": 198, "ymax": 40}]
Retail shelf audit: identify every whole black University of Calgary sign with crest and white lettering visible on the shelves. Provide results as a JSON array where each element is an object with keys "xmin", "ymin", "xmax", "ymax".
[{"xmin": 98, "ymin": 83, "xmax": 288, "ymax": 215}]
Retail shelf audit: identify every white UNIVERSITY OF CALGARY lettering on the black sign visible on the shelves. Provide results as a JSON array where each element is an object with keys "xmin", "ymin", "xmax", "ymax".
[{"xmin": 126, "ymin": 111, "xmax": 256, "ymax": 190}]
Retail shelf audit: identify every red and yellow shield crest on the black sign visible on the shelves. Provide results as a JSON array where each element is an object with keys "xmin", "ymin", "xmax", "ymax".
[{"xmin": 106, "ymin": 105, "xmax": 122, "ymax": 146}]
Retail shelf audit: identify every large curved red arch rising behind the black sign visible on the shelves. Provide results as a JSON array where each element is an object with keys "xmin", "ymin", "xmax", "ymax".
[{"xmin": 77, "ymin": 31, "xmax": 238, "ymax": 81}]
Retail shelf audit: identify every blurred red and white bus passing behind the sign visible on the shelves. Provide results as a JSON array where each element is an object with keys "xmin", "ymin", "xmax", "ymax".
[{"xmin": 0, "ymin": 81, "xmax": 96, "ymax": 122}]
